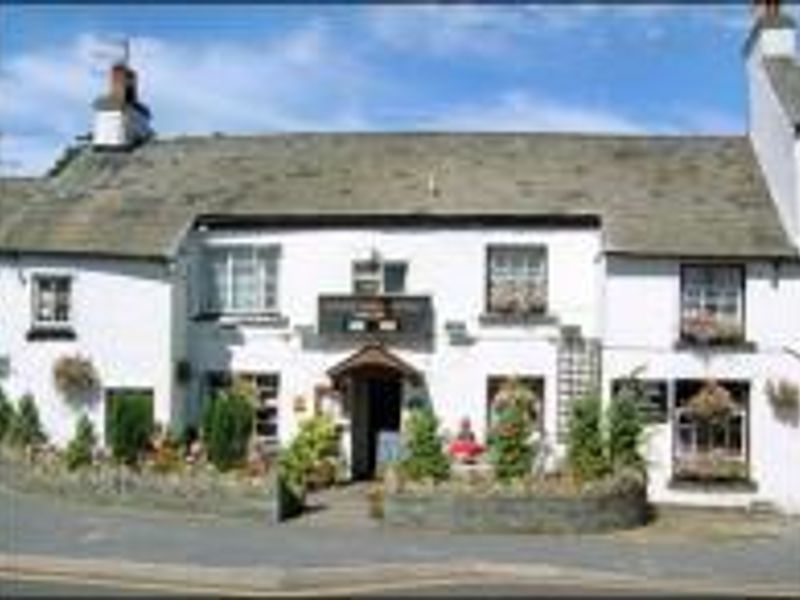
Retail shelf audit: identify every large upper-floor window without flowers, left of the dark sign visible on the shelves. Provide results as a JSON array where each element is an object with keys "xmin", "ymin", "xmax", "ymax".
[{"xmin": 204, "ymin": 246, "xmax": 279, "ymax": 314}]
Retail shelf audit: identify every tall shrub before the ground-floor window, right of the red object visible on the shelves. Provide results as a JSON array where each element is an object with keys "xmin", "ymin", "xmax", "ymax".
[{"xmin": 489, "ymin": 379, "xmax": 535, "ymax": 481}]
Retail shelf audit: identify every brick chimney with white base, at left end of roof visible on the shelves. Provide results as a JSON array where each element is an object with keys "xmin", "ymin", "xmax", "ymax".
[{"xmin": 92, "ymin": 61, "xmax": 152, "ymax": 149}]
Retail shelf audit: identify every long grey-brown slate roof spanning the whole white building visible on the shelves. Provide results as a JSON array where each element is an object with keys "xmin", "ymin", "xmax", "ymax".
[{"xmin": 0, "ymin": 133, "xmax": 795, "ymax": 257}]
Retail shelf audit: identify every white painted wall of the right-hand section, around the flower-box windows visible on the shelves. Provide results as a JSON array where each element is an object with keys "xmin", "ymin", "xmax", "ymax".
[{"xmin": 603, "ymin": 257, "xmax": 800, "ymax": 512}]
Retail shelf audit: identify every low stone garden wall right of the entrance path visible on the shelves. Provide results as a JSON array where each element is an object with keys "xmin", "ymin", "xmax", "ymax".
[{"xmin": 383, "ymin": 483, "xmax": 648, "ymax": 533}]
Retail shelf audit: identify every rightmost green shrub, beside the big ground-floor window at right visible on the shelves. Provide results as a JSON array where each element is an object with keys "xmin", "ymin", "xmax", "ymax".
[{"xmin": 606, "ymin": 386, "xmax": 643, "ymax": 470}]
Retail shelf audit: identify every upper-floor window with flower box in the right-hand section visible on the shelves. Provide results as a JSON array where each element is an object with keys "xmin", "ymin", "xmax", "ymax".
[{"xmin": 681, "ymin": 265, "xmax": 744, "ymax": 342}]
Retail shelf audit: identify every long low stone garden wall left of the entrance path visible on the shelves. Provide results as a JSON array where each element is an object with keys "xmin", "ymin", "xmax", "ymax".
[{"xmin": 0, "ymin": 449, "xmax": 302, "ymax": 523}]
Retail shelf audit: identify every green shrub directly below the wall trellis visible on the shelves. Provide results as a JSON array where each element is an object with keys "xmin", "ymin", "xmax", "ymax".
[{"xmin": 567, "ymin": 394, "xmax": 609, "ymax": 481}]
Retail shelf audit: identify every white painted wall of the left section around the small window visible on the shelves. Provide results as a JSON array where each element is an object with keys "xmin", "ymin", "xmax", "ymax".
[{"xmin": 0, "ymin": 256, "xmax": 173, "ymax": 444}]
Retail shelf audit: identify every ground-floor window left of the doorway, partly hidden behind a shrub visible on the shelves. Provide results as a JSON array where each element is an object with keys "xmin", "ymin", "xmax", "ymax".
[{"xmin": 206, "ymin": 371, "xmax": 280, "ymax": 442}]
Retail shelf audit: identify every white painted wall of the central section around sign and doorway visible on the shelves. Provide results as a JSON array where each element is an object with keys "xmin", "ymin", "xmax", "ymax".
[{"xmin": 184, "ymin": 229, "xmax": 600, "ymax": 448}]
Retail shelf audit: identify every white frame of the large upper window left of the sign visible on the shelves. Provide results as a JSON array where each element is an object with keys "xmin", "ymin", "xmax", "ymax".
[{"xmin": 202, "ymin": 244, "xmax": 281, "ymax": 316}]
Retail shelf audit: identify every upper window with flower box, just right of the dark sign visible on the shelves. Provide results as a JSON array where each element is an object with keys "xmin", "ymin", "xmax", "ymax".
[{"xmin": 487, "ymin": 245, "xmax": 547, "ymax": 314}]
